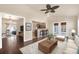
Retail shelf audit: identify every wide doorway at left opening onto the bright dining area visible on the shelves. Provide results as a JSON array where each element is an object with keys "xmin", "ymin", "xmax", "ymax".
[{"xmin": 0, "ymin": 14, "xmax": 24, "ymax": 54}]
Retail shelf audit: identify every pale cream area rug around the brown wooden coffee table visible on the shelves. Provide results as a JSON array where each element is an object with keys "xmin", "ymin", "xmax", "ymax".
[{"xmin": 20, "ymin": 39, "xmax": 77, "ymax": 54}]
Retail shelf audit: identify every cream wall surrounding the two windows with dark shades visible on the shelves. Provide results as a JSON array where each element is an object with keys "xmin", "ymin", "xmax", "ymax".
[{"xmin": 47, "ymin": 15, "xmax": 77, "ymax": 36}]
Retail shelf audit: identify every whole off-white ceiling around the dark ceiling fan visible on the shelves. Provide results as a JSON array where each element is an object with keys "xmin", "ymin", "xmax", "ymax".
[{"xmin": 0, "ymin": 4, "xmax": 79, "ymax": 19}]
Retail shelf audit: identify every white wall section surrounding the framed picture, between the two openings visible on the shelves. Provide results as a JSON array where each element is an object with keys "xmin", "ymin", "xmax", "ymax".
[{"xmin": 24, "ymin": 16, "xmax": 46, "ymax": 42}]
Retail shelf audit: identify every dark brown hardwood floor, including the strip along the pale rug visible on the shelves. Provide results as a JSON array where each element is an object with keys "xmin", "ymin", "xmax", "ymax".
[{"xmin": 0, "ymin": 37, "xmax": 43, "ymax": 54}]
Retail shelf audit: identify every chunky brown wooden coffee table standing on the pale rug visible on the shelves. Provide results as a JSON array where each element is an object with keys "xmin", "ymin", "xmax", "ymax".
[{"xmin": 38, "ymin": 40, "xmax": 57, "ymax": 53}]
